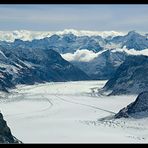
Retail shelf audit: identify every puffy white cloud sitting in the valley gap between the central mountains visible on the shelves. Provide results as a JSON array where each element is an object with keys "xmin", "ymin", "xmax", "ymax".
[{"xmin": 61, "ymin": 49, "xmax": 106, "ymax": 62}]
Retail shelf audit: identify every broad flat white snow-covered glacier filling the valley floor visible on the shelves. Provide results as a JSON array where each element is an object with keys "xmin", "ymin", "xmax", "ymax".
[{"xmin": 0, "ymin": 81, "xmax": 148, "ymax": 143}]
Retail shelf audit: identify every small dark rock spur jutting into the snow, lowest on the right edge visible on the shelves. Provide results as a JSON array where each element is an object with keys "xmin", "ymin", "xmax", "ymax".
[{"xmin": 115, "ymin": 91, "xmax": 148, "ymax": 118}]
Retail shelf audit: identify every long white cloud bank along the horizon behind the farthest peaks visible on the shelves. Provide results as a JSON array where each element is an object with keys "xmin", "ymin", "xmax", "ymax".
[{"xmin": 0, "ymin": 29, "xmax": 125, "ymax": 42}]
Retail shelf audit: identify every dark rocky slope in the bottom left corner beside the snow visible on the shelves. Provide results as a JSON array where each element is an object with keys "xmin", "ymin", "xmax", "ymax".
[{"xmin": 0, "ymin": 113, "xmax": 21, "ymax": 144}]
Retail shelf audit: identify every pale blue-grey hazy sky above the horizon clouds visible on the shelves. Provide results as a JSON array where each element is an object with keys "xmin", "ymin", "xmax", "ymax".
[{"xmin": 0, "ymin": 4, "xmax": 148, "ymax": 32}]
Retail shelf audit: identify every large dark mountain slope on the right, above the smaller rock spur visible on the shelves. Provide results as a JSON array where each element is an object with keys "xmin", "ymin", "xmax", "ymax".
[{"xmin": 103, "ymin": 55, "xmax": 148, "ymax": 95}]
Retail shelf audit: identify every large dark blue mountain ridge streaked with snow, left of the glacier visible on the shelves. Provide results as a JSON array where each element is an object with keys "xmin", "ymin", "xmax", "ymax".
[{"xmin": 0, "ymin": 44, "xmax": 89, "ymax": 91}]
